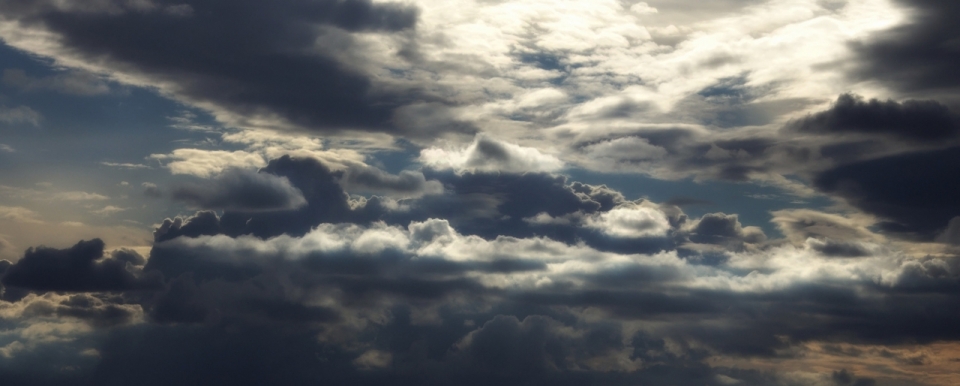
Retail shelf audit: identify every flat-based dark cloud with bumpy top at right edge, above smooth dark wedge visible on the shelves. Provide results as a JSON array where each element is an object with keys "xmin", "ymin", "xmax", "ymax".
[{"xmin": 787, "ymin": 94, "xmax": 960, "ymax": 141}]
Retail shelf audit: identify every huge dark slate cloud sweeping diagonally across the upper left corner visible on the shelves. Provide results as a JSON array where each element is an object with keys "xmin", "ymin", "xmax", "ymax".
[{"xmin": 0, "ymin": 0, "xmax": 423, "ymax": 134}]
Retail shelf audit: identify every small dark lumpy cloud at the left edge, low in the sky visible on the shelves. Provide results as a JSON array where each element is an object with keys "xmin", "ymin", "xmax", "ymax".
[{"xmin": 0, "ymin": 239, "xmax": 158, "ymax": 292}]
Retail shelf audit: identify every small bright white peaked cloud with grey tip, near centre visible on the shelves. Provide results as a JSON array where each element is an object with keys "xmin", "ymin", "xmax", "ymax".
[{"xmin": 420, "ymin": 135, "xmax": 564, "ymax": 173}]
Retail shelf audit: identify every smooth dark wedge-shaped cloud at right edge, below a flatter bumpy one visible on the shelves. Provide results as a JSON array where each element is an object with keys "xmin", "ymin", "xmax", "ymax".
[{"xmin": 813, "ymin": 147, "xmax": 960, "ymax": 239}]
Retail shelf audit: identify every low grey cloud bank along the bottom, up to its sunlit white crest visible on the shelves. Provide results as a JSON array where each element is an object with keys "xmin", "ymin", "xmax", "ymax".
[{"xmin": 5, "ymin": 208, "xmax": 960, "ymax": 385}]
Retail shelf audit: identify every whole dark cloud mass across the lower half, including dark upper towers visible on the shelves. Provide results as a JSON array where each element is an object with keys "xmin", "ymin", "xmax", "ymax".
[{"xmin": 0, "ymin": 157, "xmax": 960, "ymax": 385}]
